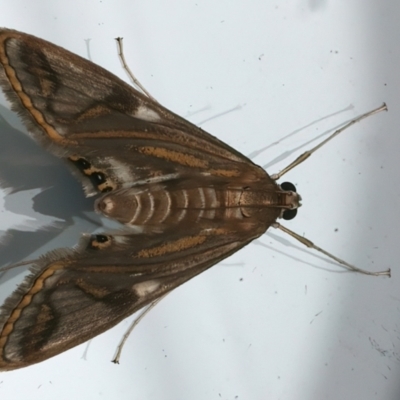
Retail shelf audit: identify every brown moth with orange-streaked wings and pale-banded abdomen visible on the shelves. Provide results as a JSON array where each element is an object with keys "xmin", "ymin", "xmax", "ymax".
[{"xmin": 0, "ymin": 29, "xmax": 388, "ymax": 371}]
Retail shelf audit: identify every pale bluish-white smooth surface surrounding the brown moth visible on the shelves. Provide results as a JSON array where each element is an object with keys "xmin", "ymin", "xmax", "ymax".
[{"xmin": 0, "ymin": 0, "xmax": 400, "ymax": 400}]
